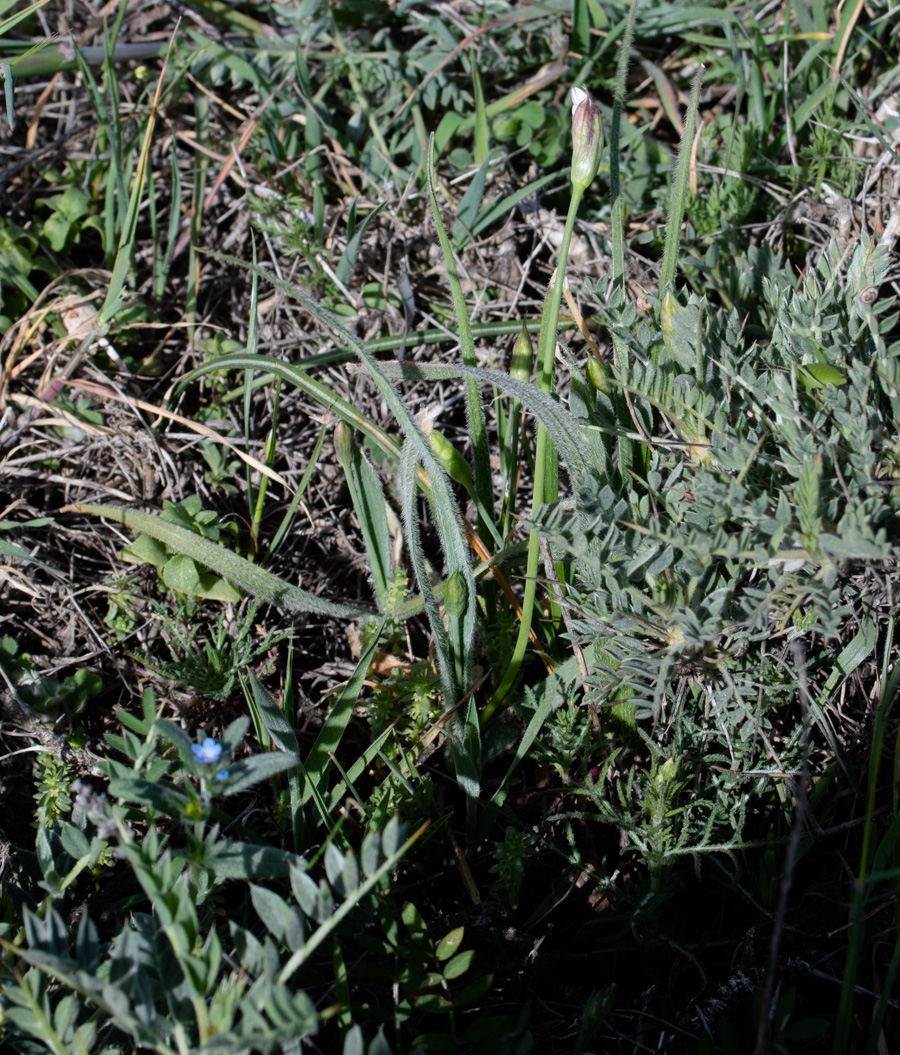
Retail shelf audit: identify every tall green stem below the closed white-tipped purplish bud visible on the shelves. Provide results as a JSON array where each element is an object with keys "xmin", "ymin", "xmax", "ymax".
[{"xmin": 481, "ymin": 186, "xmax": 583, "ymax": 724}]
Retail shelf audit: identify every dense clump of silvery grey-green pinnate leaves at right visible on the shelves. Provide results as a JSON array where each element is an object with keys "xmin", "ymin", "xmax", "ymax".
[{"xmin": 533, "ymin": 237, "xmax": 900, "ymax": 873}]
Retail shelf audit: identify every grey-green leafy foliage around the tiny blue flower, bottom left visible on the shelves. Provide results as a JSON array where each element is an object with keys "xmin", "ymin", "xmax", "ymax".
[{"xmin": 0, "ymin": 703, "xmax": 404, "ymax": 1055}]
